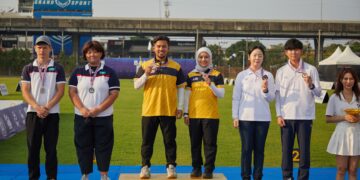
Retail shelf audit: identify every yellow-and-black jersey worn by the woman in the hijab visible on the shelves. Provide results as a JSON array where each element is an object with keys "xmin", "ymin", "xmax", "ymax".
[{"xmin": 186, "ymin": 70, "xmax": 224, "ymax": 119}]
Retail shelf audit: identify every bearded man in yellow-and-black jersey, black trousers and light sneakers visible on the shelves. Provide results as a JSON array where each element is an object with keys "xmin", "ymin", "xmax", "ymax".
[{"xmin": 134, "ymin": 36, "xmax": 185, "ymax": 178}]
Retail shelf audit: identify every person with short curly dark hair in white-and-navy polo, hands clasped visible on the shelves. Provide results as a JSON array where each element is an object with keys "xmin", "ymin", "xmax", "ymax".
[{"xmin": 69, "ymin": 41, "xmax": 120, "ymax": 180}]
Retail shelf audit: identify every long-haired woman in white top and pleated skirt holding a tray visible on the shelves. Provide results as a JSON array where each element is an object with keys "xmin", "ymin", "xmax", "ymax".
[{"xmin": 326, "ymin": 68, "xmax": 360, "ymax": 180}]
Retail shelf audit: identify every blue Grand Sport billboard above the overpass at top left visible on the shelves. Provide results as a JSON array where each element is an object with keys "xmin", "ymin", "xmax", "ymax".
[{"xmin": 34, "ymin": 0, "xmax": 92, "ymax": 12}]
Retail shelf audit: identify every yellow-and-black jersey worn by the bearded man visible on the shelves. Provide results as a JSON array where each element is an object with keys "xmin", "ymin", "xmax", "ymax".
[{"xmin": 135, "ymin": 59, "xmax": 186, "ymax": 116}]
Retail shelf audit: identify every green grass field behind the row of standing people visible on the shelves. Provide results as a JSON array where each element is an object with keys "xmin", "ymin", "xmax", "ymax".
[{"xmin": 0, "ymin": 77, "xmax": 335, "ymax": 167}]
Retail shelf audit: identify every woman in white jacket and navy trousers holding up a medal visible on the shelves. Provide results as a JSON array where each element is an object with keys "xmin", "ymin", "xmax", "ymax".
[{"xmin": 232, "ymin": 46, "xmax": 275, "ymax": 180}]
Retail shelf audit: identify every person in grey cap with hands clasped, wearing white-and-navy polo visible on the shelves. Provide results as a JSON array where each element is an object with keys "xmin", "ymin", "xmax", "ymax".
[{"xmin": 21, "ymin": 36, "xmax": 66, "ymax": 179}]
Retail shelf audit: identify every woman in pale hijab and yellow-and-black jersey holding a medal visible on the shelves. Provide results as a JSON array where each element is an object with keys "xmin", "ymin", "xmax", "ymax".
[{"xmin": 184, "ymin": 47, "xmax": 225, "ymax": 179}]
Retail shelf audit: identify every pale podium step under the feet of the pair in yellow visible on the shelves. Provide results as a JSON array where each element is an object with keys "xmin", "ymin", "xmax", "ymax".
[{"xmin": 119, "ymin": 173, "xmax": 226, "ymax": 180}]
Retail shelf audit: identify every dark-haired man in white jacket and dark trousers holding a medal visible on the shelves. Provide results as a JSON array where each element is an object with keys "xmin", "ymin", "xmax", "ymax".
[{"xmin": 275, "ymin": 39, "xmax": 321, "ymax": 180}]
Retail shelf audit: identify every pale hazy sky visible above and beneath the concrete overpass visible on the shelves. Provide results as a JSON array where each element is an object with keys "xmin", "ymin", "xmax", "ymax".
[{"xmin": 0, "ymin": 0, "xmax": 360, "ymax": 47}]
